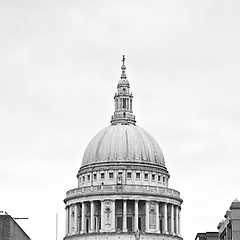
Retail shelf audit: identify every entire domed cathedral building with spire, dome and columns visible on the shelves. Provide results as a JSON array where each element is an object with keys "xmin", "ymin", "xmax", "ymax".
[{"xmin": 64, "ymin": 57, "xmax": 182, "ymax": 240}]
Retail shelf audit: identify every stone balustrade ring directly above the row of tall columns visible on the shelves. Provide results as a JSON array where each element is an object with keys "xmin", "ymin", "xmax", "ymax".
[{"xmin": 67, "ymin": 184, "xmax": 180, "ymax": 198}]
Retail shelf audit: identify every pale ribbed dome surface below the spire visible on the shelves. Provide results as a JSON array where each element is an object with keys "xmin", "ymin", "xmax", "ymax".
[{"xmin": 82, "ymin": 124, "xmax": 165, "ymax": 166}]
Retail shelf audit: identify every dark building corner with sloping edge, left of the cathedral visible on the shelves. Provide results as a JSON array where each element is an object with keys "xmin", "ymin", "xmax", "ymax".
[{"xmin": 0, "ymin": 212, "xmax": 30, "ymax": 240}]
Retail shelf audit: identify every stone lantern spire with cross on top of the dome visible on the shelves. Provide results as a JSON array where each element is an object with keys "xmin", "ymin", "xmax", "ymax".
[{"xmin": 111, "ymin": 55, "xmax": 136, "ymax": 125}]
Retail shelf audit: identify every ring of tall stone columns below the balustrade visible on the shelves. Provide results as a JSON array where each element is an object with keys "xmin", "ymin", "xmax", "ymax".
[{"xmin": 66, "ymin": 199, "xmax": 181, "ymax": 236}]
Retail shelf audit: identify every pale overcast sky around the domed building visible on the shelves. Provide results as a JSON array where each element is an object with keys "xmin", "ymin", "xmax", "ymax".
[{"xmin": 0, "ymin": 0, "xmax": 240, "ymax": 240}]
